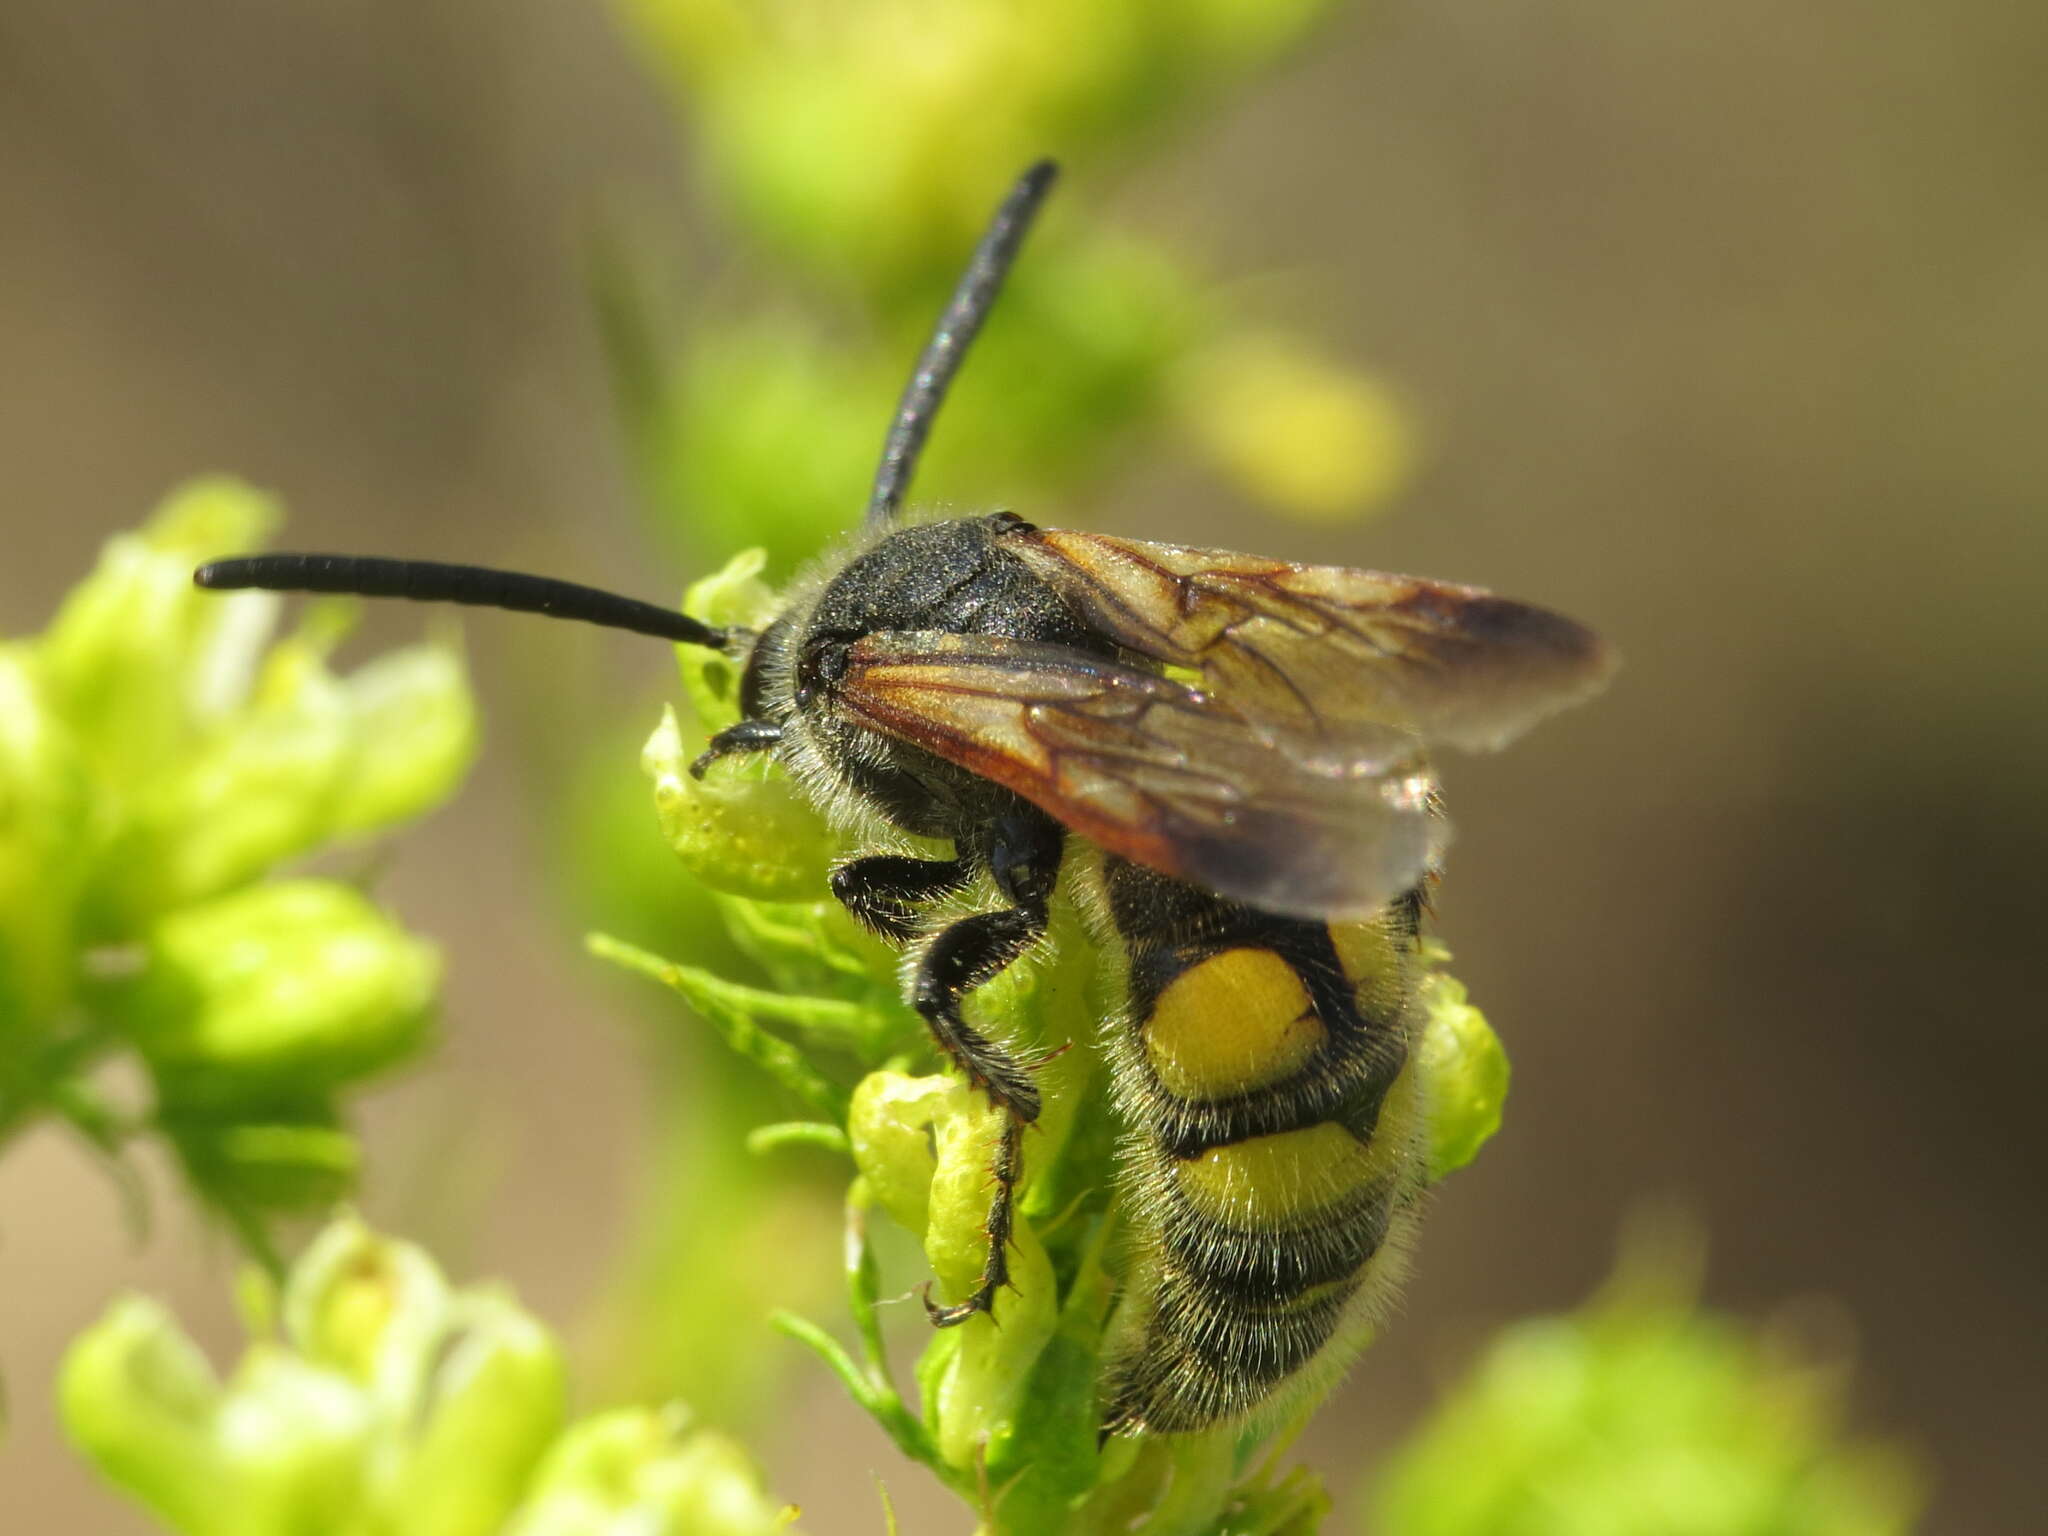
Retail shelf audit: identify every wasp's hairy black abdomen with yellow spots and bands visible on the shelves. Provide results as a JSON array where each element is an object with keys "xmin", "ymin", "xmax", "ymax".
[{"xmin": 1102, "ymin": 858, "xmax": 1421, "ymax": 1434}]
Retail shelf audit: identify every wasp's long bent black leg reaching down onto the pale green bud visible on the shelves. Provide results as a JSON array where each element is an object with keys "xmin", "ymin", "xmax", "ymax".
[{"xmin": 911, "ymin": 813, "xmax": 1065, "ymax": 1327}]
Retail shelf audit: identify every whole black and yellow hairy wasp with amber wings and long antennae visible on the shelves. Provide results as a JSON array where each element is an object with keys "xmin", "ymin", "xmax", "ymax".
[{"xmin": 195, "ymin": 162, "xmax": 1612, "ymax": 1434}]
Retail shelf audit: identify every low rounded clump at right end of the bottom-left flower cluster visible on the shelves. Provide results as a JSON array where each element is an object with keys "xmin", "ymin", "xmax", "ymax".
[{"xmin": 506, "ymin": 1409, "xmax": 797, "ymax": 1536}]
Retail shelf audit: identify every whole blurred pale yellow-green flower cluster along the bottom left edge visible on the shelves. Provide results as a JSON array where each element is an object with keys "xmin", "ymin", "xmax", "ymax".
[{"xmin": 59, "ymin": 1217, "xmax": 795, "ymax": 1536}]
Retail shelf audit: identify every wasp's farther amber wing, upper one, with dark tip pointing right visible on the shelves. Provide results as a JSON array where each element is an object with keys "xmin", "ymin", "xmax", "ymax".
[{"xmin": 1001, "ymin": 522, "xmax": 1614, "ymax": 750}]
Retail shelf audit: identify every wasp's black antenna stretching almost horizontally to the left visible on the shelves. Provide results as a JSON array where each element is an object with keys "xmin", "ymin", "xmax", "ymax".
[{"xmin": 193, "ymin": 555, "xmax": 735, "ymax": 651}]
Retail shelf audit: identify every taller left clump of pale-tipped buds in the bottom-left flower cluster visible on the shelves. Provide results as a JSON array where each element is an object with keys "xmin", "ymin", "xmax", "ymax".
[{"xmin": 59, "ymin": 1219, "xmax": 589, "ymax": 1536}]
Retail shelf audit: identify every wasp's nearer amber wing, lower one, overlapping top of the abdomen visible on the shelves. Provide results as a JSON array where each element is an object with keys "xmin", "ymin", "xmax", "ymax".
[{"xmin": 836, "ymin": 633, "xmax": 1448, "ymax": 918}]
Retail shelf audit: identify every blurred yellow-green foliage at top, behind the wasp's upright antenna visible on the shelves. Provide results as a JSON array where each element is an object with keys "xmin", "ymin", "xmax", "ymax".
[{"xmin": 598, "ymin": 0, "xmax": 1407, "ymax": 578}]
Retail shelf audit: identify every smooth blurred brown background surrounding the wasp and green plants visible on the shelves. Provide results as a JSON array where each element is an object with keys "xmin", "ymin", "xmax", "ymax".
[{"xmin": 0, "ymin": 0, "xmax": 2048, "ymax": 1536}]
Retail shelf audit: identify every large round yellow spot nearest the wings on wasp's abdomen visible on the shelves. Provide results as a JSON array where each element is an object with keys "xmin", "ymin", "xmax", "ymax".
[{"xmin": 1145, "ymin": 948, "xmax": 1323, "ymax": 1100}]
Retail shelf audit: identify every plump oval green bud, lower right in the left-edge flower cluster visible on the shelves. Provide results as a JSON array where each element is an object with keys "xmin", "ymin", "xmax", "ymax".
[{"xmin": 111, "ymin": 881, "xmax": 440, "ymax": 1106}]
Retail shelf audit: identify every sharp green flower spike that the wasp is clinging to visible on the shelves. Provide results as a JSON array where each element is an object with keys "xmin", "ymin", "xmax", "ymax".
[{"xmin": 594, "ymin": 553, "xmax": 1507, "ymax": 1536}]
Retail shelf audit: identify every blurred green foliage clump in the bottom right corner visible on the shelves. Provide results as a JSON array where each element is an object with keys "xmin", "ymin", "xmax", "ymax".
[{"xmin": 1362, "ymin": 1247, "xmax": 1925, "ymax": 1536}]
